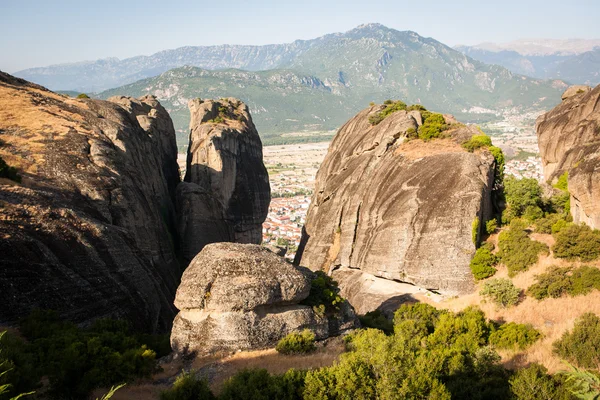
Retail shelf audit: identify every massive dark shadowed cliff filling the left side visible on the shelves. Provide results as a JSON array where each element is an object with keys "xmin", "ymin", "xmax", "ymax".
[{"xmin": 0, "ymin": 72, "xmax": 181, "ymax": 330}]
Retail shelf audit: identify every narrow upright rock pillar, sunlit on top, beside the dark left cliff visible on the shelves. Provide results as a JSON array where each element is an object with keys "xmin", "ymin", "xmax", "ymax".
[{"xmin": 177, "ymin": 98, "xmax": 271, "ymax": 261}]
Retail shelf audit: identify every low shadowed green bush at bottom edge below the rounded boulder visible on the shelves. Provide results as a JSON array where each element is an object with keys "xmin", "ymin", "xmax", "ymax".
[{"xmin": 219, "ymin": 369, "xmax": 306, "ymax": 400}]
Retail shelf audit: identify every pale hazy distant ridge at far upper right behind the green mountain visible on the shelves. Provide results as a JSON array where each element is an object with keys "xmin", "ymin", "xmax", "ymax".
[{"xmin": 455, "ymin": 39, "xmax": 600, "ymax": 85}]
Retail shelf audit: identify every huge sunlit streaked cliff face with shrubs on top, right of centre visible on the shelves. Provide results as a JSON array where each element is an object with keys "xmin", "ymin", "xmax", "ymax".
[{"xmin": 296, "ymin": 106, "xmax": 494, "ymax": 296}]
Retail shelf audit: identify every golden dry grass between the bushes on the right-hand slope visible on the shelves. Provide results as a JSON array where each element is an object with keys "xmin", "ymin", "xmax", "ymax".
[{"xmin": 434, "ymin": 234, "xmax": 600, "ymax": 372}]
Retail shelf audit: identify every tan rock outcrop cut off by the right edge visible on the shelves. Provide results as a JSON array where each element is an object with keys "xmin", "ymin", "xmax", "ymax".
[{"xmin": 536, "ymin": 86, "xmax": 600, "ymax": 229}]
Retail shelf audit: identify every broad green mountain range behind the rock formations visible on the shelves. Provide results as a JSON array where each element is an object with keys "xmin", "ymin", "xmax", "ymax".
[{"xmin": 16, "ymin": 24, "xmax": 566, "ymax": 143}]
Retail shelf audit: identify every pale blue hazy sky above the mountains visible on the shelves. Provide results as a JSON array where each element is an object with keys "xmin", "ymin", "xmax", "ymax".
[{"xmin": 0, "ymin": 0, "xmax": 600, "ymax": 72}]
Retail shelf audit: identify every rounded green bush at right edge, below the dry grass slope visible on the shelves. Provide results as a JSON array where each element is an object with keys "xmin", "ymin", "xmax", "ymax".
[{"xmin": 553, "ymin": 313, "xmax": 600, "ymax": 368}]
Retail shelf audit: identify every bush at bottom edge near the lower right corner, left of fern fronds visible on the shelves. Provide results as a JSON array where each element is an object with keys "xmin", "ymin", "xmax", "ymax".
[{"xmin": 509, "ymin": 363, "xmax": 571, "ymax": 400}]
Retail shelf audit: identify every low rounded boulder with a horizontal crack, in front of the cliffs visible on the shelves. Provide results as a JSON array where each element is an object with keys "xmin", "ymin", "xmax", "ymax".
[{"xmin": 171, "ymin": 243, "xmax": 329, "ymax": 354}]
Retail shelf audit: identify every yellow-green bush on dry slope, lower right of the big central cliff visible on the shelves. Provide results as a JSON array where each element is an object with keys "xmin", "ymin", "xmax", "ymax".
[{"xmin": 498, "ymin": 219, "xmax": 548, "ymax": 277}]
